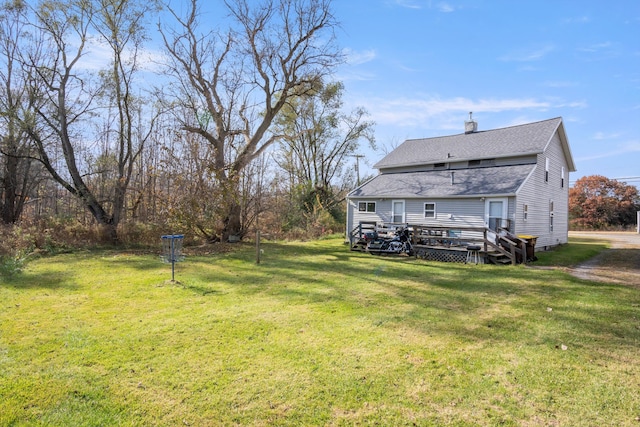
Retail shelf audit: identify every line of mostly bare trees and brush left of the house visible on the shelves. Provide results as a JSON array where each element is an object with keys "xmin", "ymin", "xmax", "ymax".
[{"xmin": 0, "ymin": 0, "xmax": 374, "ymax": 242}]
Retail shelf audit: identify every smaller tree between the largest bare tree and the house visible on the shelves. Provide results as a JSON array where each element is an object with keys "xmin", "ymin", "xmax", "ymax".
[{"xmin": 276, "ymin": 82, "xmax": 375, "ymax": 227}]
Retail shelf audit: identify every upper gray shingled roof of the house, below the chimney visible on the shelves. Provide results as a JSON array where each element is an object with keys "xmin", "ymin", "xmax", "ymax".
[{"xmin": 374, "ymin": 117, "xmax": 576, "ymax": 172}]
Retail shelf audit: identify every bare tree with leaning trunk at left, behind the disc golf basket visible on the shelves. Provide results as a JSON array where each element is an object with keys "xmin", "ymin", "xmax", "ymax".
[{"xmin": 25, "ymin": 0, "xmax": 156, "ymax": 242}]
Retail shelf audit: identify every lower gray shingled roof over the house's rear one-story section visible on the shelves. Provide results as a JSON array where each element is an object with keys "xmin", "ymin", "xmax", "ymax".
[{"xmin": 348, "ymin": 164, "xmax": 536, "ymax": 199}]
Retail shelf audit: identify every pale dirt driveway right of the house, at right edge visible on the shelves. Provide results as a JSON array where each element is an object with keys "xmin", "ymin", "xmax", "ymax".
[{"xmin": 569, "ymin": 231, "xmax": 640, "ymax": 289}]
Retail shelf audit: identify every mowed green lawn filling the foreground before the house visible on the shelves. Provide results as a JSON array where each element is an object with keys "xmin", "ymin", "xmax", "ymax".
[{"xmin": 0, "ymin": 238, "xmax": 640, "ymax": 426}]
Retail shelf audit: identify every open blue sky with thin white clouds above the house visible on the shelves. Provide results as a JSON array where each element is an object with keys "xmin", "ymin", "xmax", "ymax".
[{"xmin": 334, "ymin": 0, "xmax": 640, "ymax": 185}]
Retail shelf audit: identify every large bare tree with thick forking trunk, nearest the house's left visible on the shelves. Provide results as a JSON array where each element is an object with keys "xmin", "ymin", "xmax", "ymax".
[{"xmin": 161, "ymin": 0, "xmax": 342, "ymax": 239}]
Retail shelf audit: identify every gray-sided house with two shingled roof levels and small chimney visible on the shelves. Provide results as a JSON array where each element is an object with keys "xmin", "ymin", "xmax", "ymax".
[{"xmin": 347, "ymin": 117, "xmax": 576, "ymax": 249}]
